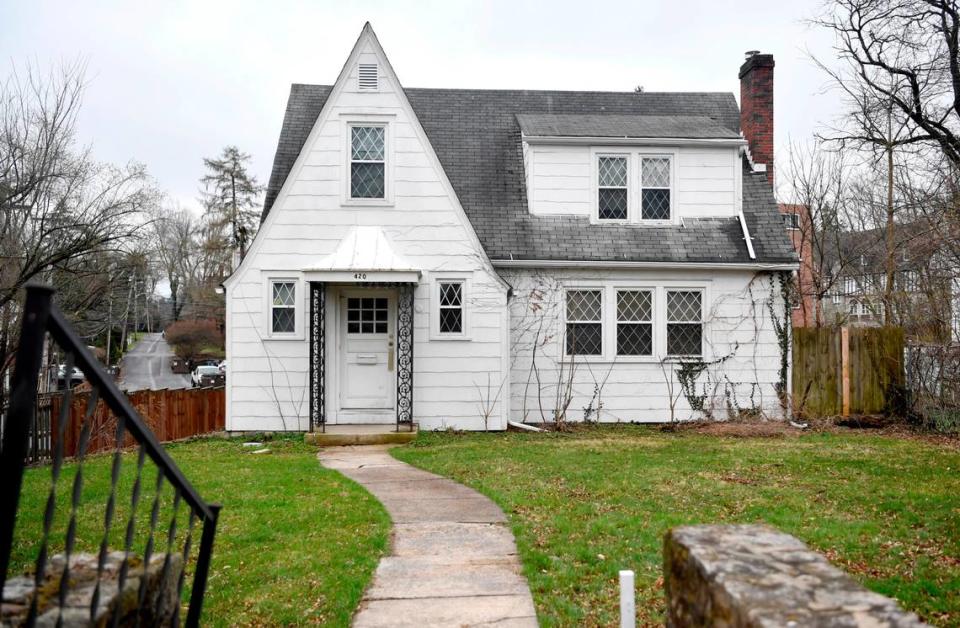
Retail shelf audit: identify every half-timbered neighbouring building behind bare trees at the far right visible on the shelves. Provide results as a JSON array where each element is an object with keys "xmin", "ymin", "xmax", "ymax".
[{"xmin": 821, "ymin": 220, "xmax": 960, "ymax": 341}]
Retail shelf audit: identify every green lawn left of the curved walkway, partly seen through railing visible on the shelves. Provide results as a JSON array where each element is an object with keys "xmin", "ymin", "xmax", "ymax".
[{"xmin": 11, "ymin": 437, "xmax": 390, "ymax": 626}]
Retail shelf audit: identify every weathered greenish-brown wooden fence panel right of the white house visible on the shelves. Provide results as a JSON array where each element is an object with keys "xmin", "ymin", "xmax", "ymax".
[{"xmin": 793, "ymin": 327, "xmax": 904, "ymax": 416}]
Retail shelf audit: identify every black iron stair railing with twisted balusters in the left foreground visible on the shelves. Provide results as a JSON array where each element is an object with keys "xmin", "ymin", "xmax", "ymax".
[{"xmin": 0, "ymin": 285, "xmax": 220, "ymax": 626}]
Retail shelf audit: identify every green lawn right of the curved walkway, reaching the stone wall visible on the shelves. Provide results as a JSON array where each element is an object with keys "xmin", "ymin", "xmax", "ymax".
[{"xmin": 393, "ymin": 426, "xmax": 960, "ymax": 626}]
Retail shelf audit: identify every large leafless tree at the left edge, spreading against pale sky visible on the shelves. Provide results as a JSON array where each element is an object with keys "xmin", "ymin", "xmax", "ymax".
[{"xmin": 0, "ymin": 64, "xmax": 153, "ymax": 397}]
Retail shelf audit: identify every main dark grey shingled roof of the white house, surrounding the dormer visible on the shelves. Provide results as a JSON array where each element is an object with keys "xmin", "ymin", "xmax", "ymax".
[{"xmin": 261, "ymin": 84, "xmax": 796, "ymax": 263}]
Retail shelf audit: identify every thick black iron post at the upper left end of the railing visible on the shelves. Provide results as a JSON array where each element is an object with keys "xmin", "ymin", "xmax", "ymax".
[{"xmin": 0, "ymin": 284, "xmax": 53, "ymax": 587}]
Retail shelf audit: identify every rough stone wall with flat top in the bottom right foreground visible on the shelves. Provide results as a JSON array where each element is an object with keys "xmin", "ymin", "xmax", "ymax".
[{"xmin": 663, "ymin": 525, "xmax": 926, "ymax": 628}]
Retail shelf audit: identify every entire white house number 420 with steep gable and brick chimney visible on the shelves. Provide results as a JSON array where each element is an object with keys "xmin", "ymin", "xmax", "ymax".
[{"xmin": 225, "ymin": 24, "xmax": 797, "ymax": 430}]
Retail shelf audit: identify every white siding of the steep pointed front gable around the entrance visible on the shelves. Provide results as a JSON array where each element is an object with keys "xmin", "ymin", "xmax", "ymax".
[{"xmin": 227, "ymin": 29, "xmax": 509, "ymax": 430}]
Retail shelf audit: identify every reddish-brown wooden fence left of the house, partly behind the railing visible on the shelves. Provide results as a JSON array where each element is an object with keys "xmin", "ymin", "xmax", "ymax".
[{"xmin": 47, "ymin": 388, "xmax": 226, "ymax": 462}]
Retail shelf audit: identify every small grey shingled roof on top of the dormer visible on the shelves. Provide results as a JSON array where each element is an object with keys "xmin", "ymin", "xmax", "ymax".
[{"xmin": 517, "ymin": 113, "xmax": 740, "ymax": 139}]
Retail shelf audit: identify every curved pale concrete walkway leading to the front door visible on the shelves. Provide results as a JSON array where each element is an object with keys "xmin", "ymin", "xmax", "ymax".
[{"xmin": 320, "ymin": 446, "xmax": 537, "ymax": 628}]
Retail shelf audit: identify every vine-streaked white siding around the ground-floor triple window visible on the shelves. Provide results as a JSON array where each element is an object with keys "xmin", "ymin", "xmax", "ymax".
[{"xmin": 504, "ymin": 270, "xmax": 783, "ymax": 422}]
